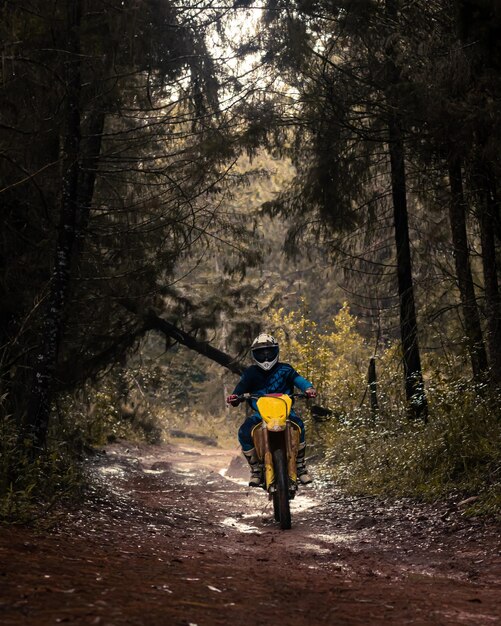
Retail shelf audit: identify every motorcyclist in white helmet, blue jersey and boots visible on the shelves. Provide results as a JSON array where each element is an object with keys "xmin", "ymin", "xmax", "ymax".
[{"xmin": 226, "ymin": 333, "xmax": 317, "ymax": 487}]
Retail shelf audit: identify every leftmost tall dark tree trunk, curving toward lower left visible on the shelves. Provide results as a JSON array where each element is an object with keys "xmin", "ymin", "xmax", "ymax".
[{"xmin": 26, "ymin": 0, "xmax": 81, "ymax": 450}]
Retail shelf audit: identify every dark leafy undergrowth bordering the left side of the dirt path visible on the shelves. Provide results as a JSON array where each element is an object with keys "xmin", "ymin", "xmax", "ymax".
[{"xmin": 0, "ymin": 376, "xmax": 160, "ymax": 524}]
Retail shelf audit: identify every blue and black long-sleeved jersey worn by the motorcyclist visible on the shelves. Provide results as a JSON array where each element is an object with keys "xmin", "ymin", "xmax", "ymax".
[{"xmin": 233, "ymin": 363, "xmax": 313, "ymax": 409}]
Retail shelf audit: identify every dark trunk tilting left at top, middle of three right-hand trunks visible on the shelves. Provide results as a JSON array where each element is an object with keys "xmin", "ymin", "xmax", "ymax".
[{"xmin": 449, "ymin": 157, "xmax": 487, "ymax": 380}]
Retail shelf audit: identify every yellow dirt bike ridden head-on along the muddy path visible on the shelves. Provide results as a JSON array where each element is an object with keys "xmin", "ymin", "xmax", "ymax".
[{"xmin": 238, "ymin": 393, "xmax": 307, "ymax": 530}]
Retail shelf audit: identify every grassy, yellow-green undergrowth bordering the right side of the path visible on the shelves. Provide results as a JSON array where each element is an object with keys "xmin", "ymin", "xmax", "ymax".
[{"xmin": 320, "ymin": 390, "xmax": 501, "ymax": 516}]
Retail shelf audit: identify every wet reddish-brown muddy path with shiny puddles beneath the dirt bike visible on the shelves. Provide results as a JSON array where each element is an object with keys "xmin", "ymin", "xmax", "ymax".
[{"xmin": 0, "ymin": 444, "xmax": 501, "ymax": 626}]
